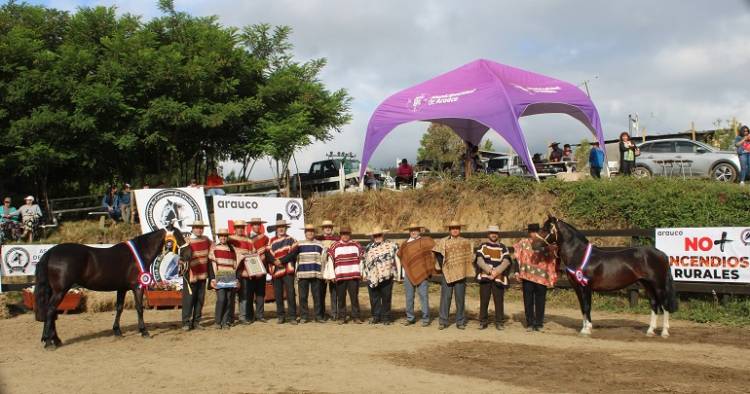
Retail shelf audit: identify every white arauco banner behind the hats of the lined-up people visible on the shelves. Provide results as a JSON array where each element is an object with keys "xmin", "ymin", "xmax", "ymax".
[{"xmin": 213, "ymin": 196, "xmax": 305, "ymax": 240}]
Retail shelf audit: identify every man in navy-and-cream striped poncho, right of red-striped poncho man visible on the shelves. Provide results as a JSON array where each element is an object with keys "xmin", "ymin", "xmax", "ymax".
[{"xmin": 297, "ymin": 224, "xmax": 327, "ymax": 323}]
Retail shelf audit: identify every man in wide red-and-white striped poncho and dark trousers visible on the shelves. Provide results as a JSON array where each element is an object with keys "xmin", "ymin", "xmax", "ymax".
[{"xmin": 328, "ymin": 226, "xmax": 364, "ymax": 324}]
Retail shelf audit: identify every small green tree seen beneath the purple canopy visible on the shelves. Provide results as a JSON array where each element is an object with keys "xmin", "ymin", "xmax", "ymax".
[{"xmin": 417, "ymin": 123, "xmax": 466, "ymax": 168}]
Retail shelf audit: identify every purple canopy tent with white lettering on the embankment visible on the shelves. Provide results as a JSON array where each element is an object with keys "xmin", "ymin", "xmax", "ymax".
[{"xmin": 359, "ymin": 59, "xmax": 606, "ymax": 179}]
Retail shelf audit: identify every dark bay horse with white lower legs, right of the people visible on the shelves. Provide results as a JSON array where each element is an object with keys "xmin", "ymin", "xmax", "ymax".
[{"xmin": 535, "ymin": 215, "xmax": 677, "ymax": 338}]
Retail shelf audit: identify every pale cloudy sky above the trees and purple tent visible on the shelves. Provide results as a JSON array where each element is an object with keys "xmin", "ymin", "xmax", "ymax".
[{"xmin": 31, "ymin": 0, "xmax": 750, "ymax": 179}]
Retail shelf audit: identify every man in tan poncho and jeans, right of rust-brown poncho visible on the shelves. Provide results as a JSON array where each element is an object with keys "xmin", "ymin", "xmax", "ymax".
[{"xmin": 432, "ymin": 221, "xmax": 474, "ymax": 330}]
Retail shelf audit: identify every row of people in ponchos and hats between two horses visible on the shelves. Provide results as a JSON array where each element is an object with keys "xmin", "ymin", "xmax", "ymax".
[{"xmin": 182, "ymin": 218, "xmax": 557, "ymax": 331}]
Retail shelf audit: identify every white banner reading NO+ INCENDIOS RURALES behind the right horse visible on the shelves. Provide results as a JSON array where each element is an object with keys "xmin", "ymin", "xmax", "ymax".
[{"xmin": 655, "ymin": 227, "xmax": 750, "ymax": 283}]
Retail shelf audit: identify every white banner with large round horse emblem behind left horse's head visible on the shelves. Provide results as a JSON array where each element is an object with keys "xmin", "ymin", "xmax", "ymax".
[{"xmin": 135, "ymin": 187, "xmax": 213, "ymax": 238}]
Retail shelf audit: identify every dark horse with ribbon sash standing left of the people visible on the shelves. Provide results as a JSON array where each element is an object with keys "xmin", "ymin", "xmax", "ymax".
[{"xmin": 34, "ymin": 224, "xmax": 187, "ymax": 349}]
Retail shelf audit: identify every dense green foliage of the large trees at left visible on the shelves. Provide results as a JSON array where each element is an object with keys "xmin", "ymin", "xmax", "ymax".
[{"xmin": 0, "ymin": 0, "xmax": 351, "ymax": 203}]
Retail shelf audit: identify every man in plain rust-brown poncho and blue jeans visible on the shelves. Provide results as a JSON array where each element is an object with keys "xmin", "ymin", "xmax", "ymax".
[{"xmin": 397, "ymin": 223, "xmax": 435, "ymax": 327}]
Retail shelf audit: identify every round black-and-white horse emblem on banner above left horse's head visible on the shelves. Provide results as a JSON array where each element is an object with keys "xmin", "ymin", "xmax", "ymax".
[{"xmin": 146, "ymin": 189, "xmax": 203, "ymax": 233}]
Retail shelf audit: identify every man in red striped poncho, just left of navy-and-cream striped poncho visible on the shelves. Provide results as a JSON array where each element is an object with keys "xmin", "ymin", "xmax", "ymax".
[{"xmin": 268, "ymin": 220, "xmax": 297, "ymax": 325}]
